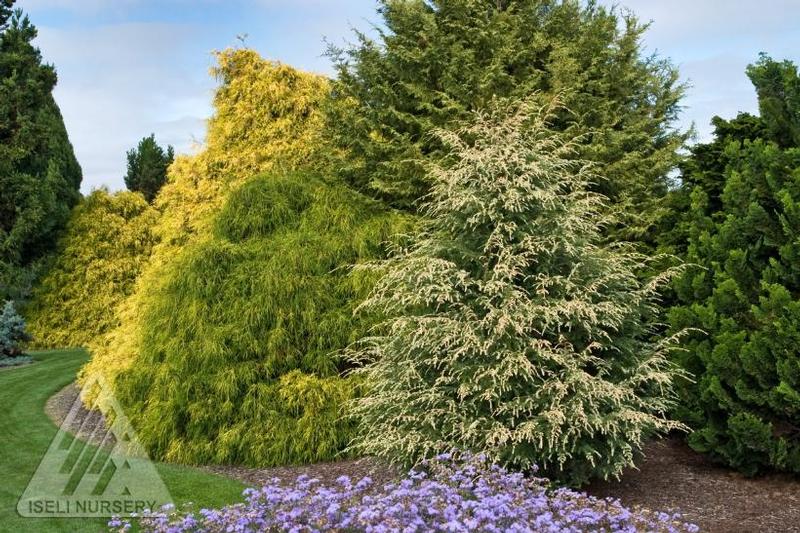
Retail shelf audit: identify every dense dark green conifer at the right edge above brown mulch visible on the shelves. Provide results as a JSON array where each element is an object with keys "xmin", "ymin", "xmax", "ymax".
[{"xmin": 666, "ymin": 56, "xmax": 800, "ymax": 474}]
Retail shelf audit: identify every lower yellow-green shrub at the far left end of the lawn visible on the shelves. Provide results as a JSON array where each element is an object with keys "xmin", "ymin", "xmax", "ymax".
[{"xmin": 25, "ymin": 189, "xmax": 158, "ymax": 348}]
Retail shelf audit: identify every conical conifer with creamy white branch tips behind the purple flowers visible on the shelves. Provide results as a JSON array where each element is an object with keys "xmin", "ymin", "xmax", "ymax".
[{"xmin": 350, "ymin": 97, "xmax": 681, "ymax": 485}]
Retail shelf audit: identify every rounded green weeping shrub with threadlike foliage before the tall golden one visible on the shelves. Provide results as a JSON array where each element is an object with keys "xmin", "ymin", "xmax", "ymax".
[{"xmin": 111, "ymin": 174, "xmax": 402, "ymax": 466}]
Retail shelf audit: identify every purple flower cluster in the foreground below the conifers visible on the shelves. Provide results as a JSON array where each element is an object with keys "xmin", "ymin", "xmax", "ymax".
[{"xmin": 109, "ymin": 455, "xmax": 698, "ymax": 533}]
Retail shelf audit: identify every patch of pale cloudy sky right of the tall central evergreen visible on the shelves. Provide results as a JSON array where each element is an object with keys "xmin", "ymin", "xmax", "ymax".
[{"xmin": 603, "ymin": 0, "xmax": 800, "ymax": 141}]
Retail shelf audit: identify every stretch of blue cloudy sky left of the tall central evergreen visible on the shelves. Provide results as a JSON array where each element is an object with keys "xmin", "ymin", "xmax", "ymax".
[{"xmin": 19, "ymin": 0, "xmax": 375, "ymax": 192}]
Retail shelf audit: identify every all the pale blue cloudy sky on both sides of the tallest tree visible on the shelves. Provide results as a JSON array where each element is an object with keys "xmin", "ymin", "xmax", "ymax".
[{"xmin": 17, "ymin": 0, "xmax": 800, "ymax": 192}]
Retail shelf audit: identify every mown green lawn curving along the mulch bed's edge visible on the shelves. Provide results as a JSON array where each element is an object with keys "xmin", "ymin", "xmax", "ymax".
[{"xmin": 0, "ymin": 350, "xmax": 244, "ymax": 533}]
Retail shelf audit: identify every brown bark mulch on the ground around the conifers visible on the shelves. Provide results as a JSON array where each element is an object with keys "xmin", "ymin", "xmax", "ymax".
[{"xmin": 45, "ymin": 385, "xmax": 800, "ymax": 533}]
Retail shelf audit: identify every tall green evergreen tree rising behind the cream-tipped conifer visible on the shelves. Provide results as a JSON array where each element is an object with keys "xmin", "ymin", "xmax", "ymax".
[{"xmin": 329, "ymin": 0, "xmax": 686, "ymax": 241}]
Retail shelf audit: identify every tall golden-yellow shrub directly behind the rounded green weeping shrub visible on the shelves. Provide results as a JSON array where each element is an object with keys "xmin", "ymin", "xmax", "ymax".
[{"xmin": 79, "ymin": 49, "xmax": 329, "ymax": 396}]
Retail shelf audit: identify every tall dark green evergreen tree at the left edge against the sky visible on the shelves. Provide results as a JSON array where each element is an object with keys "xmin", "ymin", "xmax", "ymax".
[{"xmin": 0, "ymin": 0, "xmax": 82, "ymax": 297}]
